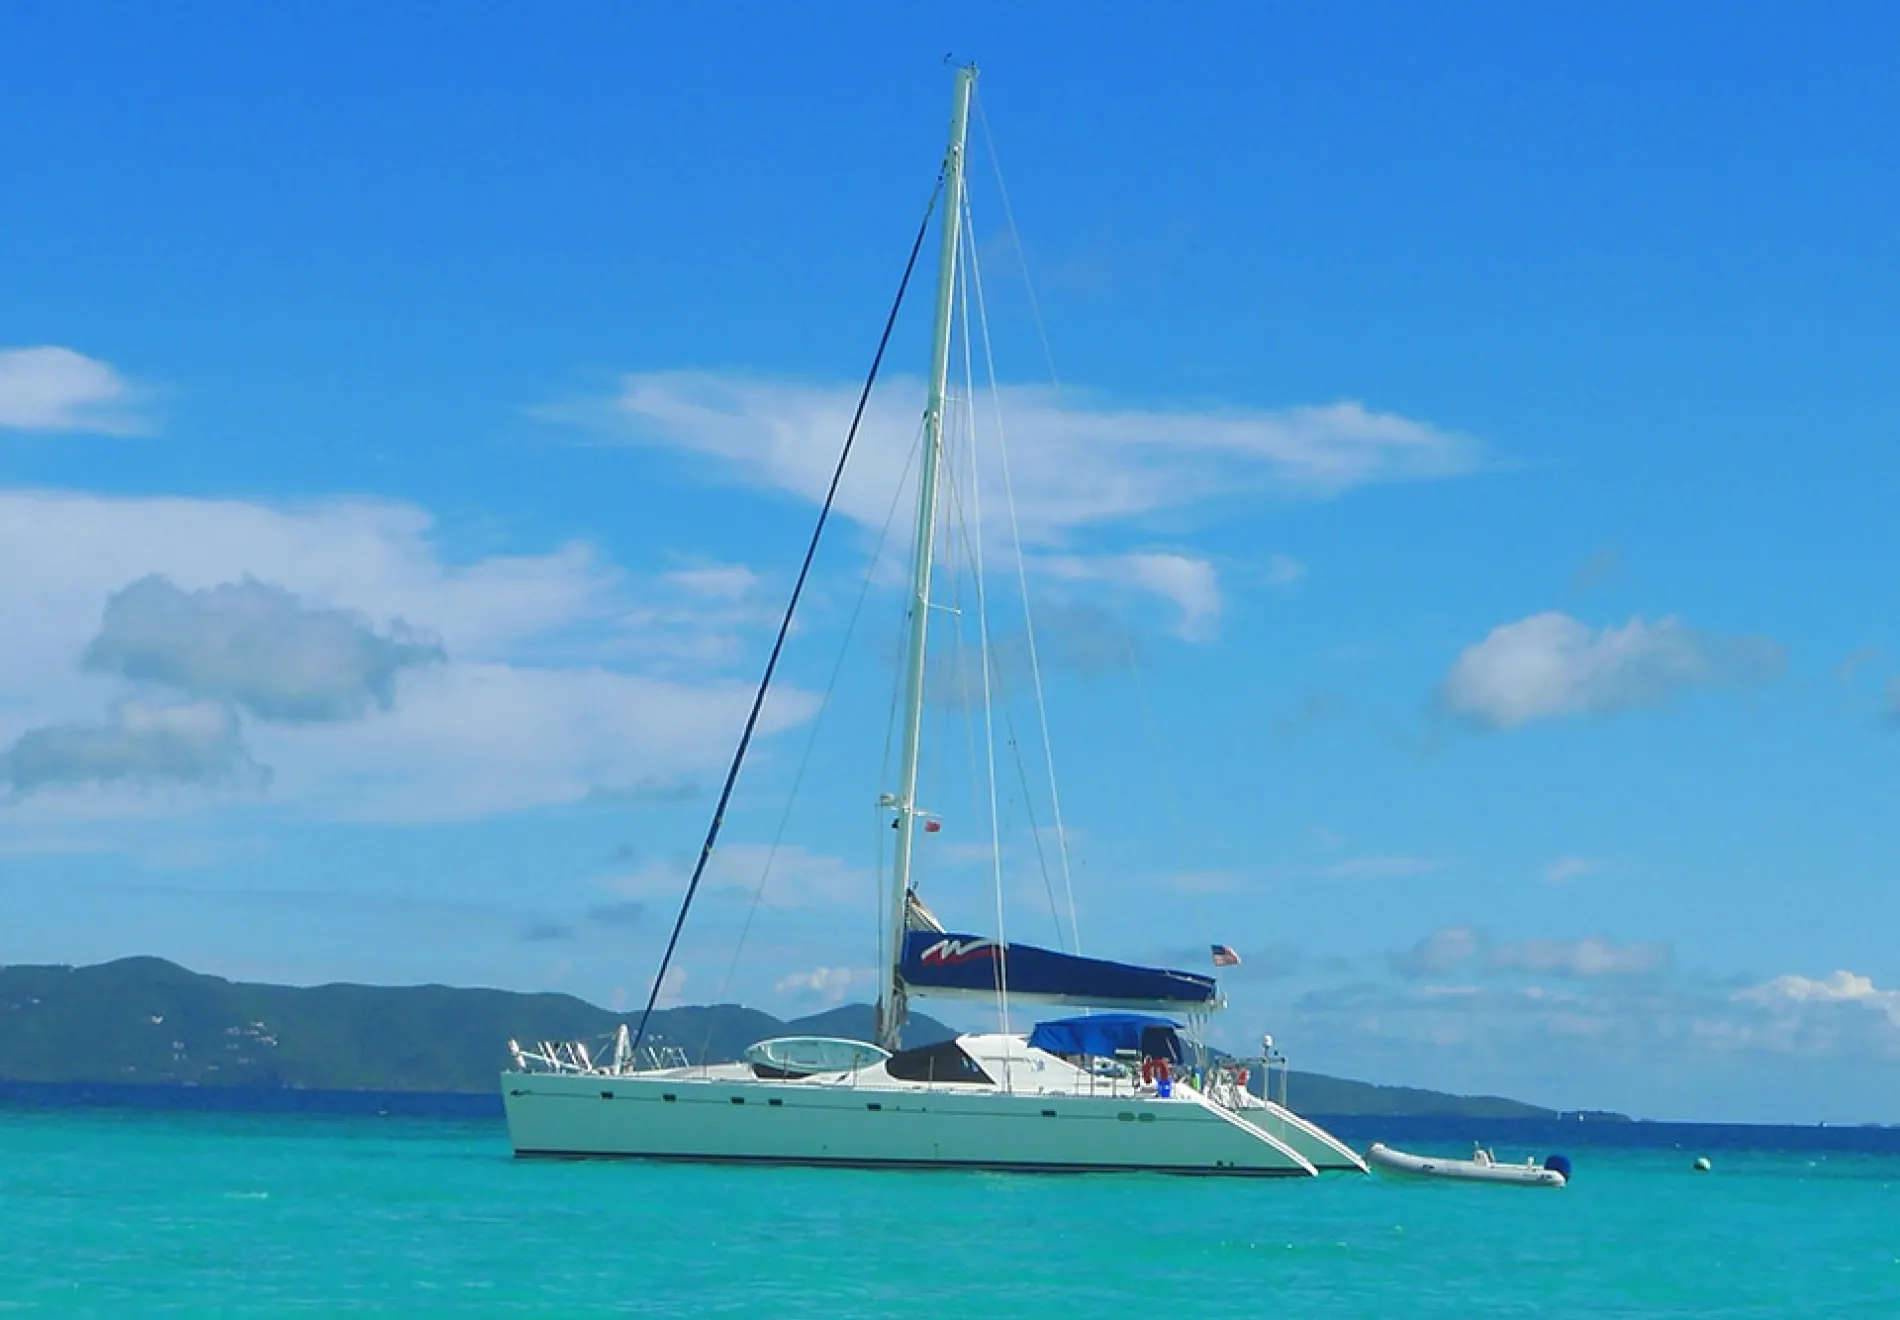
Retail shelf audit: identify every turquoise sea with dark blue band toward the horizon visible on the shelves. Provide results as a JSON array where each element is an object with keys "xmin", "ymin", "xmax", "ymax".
[{"xmin": 0, "ymin": 1086, "xmax": 1900, "ymax": 1320}]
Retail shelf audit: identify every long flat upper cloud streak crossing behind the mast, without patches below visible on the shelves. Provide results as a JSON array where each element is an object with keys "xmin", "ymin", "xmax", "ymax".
[{"xmin": 538, "ymin": 372, "xmax": 1480, "ymax": 541}]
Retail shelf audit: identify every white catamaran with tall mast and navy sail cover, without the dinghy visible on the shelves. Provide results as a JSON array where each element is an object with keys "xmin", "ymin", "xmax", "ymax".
[{"xmin": 502, "ymin": 68, "xmax": 1366, "ymax": 1176}]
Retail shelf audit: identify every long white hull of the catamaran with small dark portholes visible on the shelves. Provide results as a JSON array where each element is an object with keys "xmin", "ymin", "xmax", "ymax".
[{"xmin": 502, "ymin": 1065, "xmax": 1364, "ymax": 1178}]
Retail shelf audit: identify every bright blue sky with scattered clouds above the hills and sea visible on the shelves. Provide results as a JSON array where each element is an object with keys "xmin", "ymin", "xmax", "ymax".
[{"xmin": 0, "ymin": 4, "xmax": 1900, "ymax": 1121}]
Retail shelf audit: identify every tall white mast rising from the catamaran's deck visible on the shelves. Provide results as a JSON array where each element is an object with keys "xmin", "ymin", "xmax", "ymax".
[{"xmin": 878, "ymin": 65, "xmax": 977, "ymax": 1050}]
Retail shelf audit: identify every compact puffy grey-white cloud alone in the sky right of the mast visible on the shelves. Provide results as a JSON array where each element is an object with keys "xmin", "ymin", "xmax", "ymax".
[{"xmin": 1440, "ymin": 612, "xmax": 1780, "ymax": 729}]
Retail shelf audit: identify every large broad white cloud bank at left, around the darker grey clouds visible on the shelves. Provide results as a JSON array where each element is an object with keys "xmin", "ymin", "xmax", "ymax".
[{"xmin": 0, "ymin": 490, "xmax": 811, "ymax": 820}]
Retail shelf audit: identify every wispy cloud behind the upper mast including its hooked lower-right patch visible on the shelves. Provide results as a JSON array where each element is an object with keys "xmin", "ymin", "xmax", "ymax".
[{"xmin": 534, "ymin": 370, "xmax": 1482, "ymax": 653}]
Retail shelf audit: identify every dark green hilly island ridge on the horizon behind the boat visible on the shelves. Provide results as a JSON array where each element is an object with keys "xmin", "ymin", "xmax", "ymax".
[{"xmin": 0, "ymin": 957, "xmax": 1628, "ymax": 1122}]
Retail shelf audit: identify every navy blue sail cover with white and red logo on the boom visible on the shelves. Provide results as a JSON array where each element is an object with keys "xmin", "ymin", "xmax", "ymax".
[{"xmin": 903, "ymin": 931, "xmax": 1220, "ymax": 1010}]
